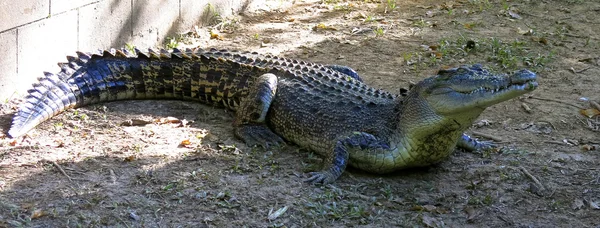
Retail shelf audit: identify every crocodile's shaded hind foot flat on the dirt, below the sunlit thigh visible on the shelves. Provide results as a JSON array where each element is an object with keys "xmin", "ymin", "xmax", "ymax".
[{"xmin": 235, "ymin": 125, "xmax": 285, "ymax": 149}]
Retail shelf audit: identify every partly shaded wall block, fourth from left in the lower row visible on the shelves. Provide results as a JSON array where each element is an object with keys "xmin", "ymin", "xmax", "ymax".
[{"xmin": 131, "ymin": 0, "xmax": 180, "ymax": 48}]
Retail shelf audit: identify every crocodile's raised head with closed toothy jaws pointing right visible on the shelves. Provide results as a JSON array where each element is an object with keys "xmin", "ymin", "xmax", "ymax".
[{"xmin": 404, "ymin": 64, "xmax": 538, "ymax": 130}]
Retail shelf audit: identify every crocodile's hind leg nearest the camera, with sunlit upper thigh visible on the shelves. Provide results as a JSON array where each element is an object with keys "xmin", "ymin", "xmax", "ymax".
[{"xmin": 234, "ymin": 73, "xmax": 283, "ymax": 148}]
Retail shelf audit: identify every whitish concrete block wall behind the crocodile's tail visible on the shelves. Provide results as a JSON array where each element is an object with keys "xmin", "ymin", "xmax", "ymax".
[{"xmin": 0, "ymin": 0, "xmax": 261, "ymax": 101}]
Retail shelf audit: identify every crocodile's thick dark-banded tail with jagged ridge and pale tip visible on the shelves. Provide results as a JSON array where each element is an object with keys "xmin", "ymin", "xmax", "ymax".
[{"xmin": 8, "ymin": 49, "xmax": 265, "ymax": 137}]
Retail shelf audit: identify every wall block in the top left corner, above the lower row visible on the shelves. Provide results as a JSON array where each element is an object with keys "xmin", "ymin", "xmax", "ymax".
[{"xmin": 0, "ymin": 0, "xmax": 50, "ymax": 32}]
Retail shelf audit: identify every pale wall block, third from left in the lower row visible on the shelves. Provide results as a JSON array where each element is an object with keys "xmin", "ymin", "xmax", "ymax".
[{"xmin": 79, "ymin": 0, "xmax": 135, "ymax": 51}]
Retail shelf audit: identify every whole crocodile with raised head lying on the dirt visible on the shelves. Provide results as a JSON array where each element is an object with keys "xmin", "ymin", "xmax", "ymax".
[{"xmin": 8, "ymin": 48, "xmax": 538, "ymax": 184}]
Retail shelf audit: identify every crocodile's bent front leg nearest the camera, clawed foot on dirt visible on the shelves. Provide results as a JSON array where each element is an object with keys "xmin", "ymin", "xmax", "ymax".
[{"xmin": 306, "ymin": 132, "xmax": 390, "ymax": 184}]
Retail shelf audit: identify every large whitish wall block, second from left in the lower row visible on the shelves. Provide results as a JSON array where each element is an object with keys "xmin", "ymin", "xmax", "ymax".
[{"xmin": 15, "ymin": 11, "xmax": 77, "ymax": 98}]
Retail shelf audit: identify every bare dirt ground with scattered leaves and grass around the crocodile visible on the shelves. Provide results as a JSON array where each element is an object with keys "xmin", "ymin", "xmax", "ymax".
[{"xmin": 0, "ymin": 0, "xmax": 600, "ymax": 227}]
